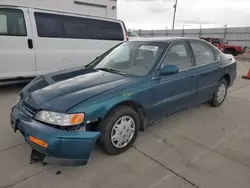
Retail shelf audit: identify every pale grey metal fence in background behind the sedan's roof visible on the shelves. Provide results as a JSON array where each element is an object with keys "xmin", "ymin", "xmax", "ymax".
[{"xmin": 136, "ymin": 27, "xmax": 250, "ymax": 47}]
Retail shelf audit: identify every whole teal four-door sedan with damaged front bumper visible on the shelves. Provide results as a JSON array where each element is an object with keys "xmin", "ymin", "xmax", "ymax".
[{"xmin": 10, "ymin": 38, "xmax": 236, "ymax": 164}]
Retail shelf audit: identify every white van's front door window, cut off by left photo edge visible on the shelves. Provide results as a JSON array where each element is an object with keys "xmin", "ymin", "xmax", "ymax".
[{"xmin": 0, "ymin": 8, "xmax": 27, "ymax": 36}]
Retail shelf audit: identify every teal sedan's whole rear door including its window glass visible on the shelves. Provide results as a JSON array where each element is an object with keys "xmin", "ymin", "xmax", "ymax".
[{"xmin": 190, "ymin": 41, "xmax": 221, "ymax": 102}]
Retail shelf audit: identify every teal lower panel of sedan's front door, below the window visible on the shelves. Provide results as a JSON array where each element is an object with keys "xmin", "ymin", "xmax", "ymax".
[{"xmin": 147, "ymin": 68, "xmax": 197, "ymax": 119}]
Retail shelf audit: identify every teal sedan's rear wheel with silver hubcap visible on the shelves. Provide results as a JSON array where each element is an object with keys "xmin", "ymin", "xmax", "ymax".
[{"xmin": 210, "ymin": 79, "xmax": 228, "ymax": 107}]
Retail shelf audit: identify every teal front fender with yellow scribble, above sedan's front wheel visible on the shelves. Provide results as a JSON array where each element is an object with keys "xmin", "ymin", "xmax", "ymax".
[{"xmin": 67, "ymin": 76, "xmax": 153, "ymax": 123}]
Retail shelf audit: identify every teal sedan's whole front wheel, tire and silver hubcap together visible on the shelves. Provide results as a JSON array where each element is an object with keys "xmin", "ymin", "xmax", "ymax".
[{"xmin": 97, "ymin": 106, "xmax": 140, "ymax": 155}]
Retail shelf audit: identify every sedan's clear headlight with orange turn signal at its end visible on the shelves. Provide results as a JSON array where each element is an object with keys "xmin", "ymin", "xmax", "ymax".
[{"xmin": 35, "ymin": 111, "xmax": 84, "ymax": 126}]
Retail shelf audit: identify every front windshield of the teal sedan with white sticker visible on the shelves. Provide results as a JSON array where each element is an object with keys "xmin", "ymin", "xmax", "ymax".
[{"xmin": 90, "ymin": 42, "xmax": 167, "ymax": 76}]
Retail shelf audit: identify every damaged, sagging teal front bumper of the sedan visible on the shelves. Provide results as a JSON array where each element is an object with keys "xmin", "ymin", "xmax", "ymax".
[{"xmin": 10, "ymin": 105, "xmax": 100, "ymax": 165}]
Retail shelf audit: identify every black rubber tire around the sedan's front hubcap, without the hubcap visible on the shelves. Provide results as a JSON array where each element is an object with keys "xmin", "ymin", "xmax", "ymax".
[{"xmin": 97, "ymin": 106, "xmax": 140, "ymax": 155}]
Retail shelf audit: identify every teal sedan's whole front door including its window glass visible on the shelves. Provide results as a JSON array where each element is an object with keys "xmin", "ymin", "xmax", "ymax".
[{"xmin": 148, "ymin": 42, "xmax": 197, "ymax": 119}]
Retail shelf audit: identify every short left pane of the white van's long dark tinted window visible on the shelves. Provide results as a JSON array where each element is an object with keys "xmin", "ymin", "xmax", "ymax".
[{"xmin": 35, "ymin": 12, "xmax": 63, "ymax": 38}]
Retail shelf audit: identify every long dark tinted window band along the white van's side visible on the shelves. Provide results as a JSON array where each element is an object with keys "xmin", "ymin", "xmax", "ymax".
[{"xmin": 35, "ymin": 13, "xmax": 124, "ymax": 41}]
